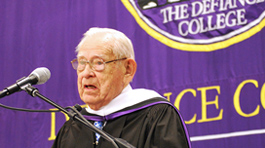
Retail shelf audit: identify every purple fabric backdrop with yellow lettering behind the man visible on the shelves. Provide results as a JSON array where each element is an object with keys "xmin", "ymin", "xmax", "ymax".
[{"xmin": 0, "ymin": 0, "xmax": 265, "ymax": 148}]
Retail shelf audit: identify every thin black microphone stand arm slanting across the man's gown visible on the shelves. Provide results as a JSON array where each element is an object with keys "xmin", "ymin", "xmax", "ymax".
[{"xmin": 22, "ymin": 85, "xmax": 135, "ymax": 148}]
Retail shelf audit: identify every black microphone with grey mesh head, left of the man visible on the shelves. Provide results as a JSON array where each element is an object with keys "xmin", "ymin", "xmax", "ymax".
[{"xmin": 0, "ymin": 67, "xmax": 51, "ymax": 98}]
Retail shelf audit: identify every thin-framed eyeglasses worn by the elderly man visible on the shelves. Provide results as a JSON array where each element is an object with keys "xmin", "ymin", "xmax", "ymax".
[{"xmin": 71, "ymin": 58, "xmax": 127, "ymax": 71}]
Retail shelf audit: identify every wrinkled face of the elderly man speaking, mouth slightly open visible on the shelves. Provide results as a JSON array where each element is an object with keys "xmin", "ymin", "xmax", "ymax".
[{"xmin": 77, "ymin": 35, "xmax": 125, "ymax": 110}]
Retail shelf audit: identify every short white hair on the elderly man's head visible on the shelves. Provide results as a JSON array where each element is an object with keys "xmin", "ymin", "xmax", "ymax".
[{"xmin": 76, "ymin": 27, "xmax": 135, "ymax": 59}]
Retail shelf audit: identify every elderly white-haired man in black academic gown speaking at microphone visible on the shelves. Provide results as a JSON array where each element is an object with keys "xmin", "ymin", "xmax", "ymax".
[{"xmin": 53, "ymin": 28, "xmax": 190, "ymax": 148}]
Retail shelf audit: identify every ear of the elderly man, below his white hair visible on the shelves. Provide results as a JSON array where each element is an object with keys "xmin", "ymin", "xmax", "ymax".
[{"xmin": 125, "ymin": 59, "xmax": 137, "ymax": 83}]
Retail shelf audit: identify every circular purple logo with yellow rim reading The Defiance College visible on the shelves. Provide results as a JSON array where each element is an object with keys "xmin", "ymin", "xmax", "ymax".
[{"xmin": 122, "ymin": 0, "xmax": 265, "ymax": 52}]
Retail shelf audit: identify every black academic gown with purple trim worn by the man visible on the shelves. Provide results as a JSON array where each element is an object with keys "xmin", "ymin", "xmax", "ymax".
[{"xmin": 53, "ymin": 98, "xmax": 191, "ymax": 148}]
